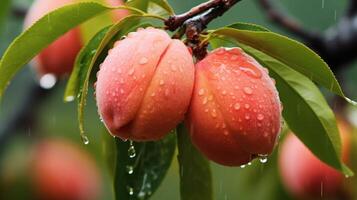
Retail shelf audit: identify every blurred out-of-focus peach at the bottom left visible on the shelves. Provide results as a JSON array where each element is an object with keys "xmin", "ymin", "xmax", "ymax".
[{"xmin": 31, "ymin": 140, "xmax": 100, "ymax": 200}]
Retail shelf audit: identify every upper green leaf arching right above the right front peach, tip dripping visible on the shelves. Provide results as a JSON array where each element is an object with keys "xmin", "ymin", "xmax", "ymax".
[{"xmin": 211, "ymin": 23, "xmax": 357, "ymax": 105}]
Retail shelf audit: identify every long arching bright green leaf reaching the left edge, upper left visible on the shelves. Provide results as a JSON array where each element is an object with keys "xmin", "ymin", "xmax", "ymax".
[{"xmin": 0, "ymin": 2, "xmax": 111, "ymax": 98}]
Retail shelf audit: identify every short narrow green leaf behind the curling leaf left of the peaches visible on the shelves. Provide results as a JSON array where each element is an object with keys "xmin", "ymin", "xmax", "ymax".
[{"xmin": 64, "ymin": 26, "xmax": 111, "ymax": 101}]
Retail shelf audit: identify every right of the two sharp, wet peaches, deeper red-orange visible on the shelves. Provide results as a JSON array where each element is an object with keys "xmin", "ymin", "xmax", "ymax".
[{"xmin": 188, "ymin": 48, "xmax": 281, "ymax": 166}]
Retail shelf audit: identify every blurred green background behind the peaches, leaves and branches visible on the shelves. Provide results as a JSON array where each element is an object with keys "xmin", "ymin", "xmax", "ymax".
[{"xmin": 0, "ymin": 0, "xmax": 357, "ymax": 200}]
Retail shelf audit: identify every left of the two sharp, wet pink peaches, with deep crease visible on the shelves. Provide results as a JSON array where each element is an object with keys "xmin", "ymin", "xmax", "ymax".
[{"xmin": 96, "ymin": 28, "xmax": 194, "ymax": 141}]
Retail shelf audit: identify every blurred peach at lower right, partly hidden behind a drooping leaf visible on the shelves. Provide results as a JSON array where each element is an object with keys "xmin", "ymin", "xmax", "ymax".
[{"xmin": 279, "ymin": 121, "xmax": 351, "ymax": 199}]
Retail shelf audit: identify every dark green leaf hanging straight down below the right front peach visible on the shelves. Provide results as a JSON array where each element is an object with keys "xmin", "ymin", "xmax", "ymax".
[{"xmin": 177, "ymin": 124, "xmax": 213, "ymax": 200}]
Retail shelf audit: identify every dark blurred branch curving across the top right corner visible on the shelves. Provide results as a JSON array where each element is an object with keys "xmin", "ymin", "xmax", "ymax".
[{"xmin": 254, "ymin": 0, "xmax": 357, "ymax": 69}]
